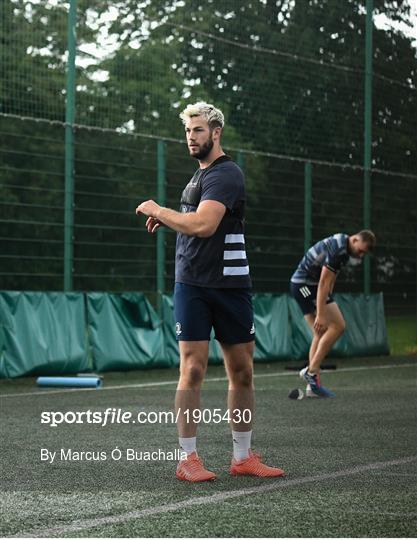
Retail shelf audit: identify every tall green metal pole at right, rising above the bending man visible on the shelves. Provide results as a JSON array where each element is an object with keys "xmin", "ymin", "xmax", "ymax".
[{"xmin": 363, "ymin": 0, "xmax": 373, "ymax": 294}]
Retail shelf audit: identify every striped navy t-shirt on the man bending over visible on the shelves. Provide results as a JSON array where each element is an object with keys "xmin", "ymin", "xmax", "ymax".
[{"xmin": 291, "ymin": 233, "xmax": 349, "ymax": 285}]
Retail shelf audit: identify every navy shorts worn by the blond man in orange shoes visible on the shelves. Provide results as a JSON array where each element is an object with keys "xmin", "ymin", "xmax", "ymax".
[{"xmin": 174, "ymin": 283, "xmax": 255, "ymax": 345}]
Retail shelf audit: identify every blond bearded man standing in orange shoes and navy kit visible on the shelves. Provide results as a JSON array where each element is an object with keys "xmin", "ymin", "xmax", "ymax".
[{"xmin": 136, "ymin": 102, "xmax": 284, "ymax": 482}]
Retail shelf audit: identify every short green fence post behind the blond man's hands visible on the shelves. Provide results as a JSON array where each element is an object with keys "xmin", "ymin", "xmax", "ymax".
[{"xmin": 156, "ymin": 140, "xmax": 166, "ymax": 319}]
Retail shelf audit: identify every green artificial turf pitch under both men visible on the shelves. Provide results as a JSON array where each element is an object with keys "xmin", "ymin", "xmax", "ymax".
[{"xmin": 0, "ymin": 356, "xmax": 417, "ymax": 537}]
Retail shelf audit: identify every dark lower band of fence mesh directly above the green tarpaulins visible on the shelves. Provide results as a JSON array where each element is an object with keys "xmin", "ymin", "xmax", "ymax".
[{"xmin": 0, "ymin": 117, "xmax": 417, "ymax": 313}]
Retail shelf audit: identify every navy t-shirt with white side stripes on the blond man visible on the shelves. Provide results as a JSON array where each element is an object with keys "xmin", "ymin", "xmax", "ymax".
[{"xmin": 175, "ymin": 156, "xmax": 251, "ymax": 288}]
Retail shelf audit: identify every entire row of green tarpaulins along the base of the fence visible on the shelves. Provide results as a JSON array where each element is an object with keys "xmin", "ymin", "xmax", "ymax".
[{"xmin": 0, "ymin": 291, "xmax": 389, "ymax": 377}]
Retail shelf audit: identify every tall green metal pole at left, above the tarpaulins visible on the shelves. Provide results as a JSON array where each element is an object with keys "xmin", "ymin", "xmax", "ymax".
[{"xmin": 64, "ymin": 0, "xmax": 77, "ymax": 291}]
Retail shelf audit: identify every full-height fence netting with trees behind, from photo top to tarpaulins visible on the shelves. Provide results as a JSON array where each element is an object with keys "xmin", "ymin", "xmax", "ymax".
[{"xmin": 0, "ymin": 0, "xmax": 417, "ymax": 314}]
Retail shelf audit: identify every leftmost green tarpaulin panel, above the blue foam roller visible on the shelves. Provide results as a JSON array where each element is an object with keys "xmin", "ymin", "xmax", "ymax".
[{"xmin": 0, "ymin": 291, "xmax": 91, "ymax": 377}]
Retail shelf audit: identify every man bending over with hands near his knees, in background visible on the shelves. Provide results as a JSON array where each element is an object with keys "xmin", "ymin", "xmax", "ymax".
[{"xmin": 290, "ymin": 230, "xmax": 376, "ymax": 397}]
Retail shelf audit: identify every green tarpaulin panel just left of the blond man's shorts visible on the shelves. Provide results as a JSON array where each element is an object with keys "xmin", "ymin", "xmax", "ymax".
[{"xmin": 87, "ymin": 292, "xmax": 172, "ymax": 371}]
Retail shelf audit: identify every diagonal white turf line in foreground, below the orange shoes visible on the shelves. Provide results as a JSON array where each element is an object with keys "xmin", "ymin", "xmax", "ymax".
[{"xmin": 14, "ymin": 456, "xmax": 417, "ymax": 538}]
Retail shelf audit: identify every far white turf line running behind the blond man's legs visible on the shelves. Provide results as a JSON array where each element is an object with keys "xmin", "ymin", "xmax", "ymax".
[{"xmin": 0, "ymin": 364, "xmax": 417, "ymax": 398}]
